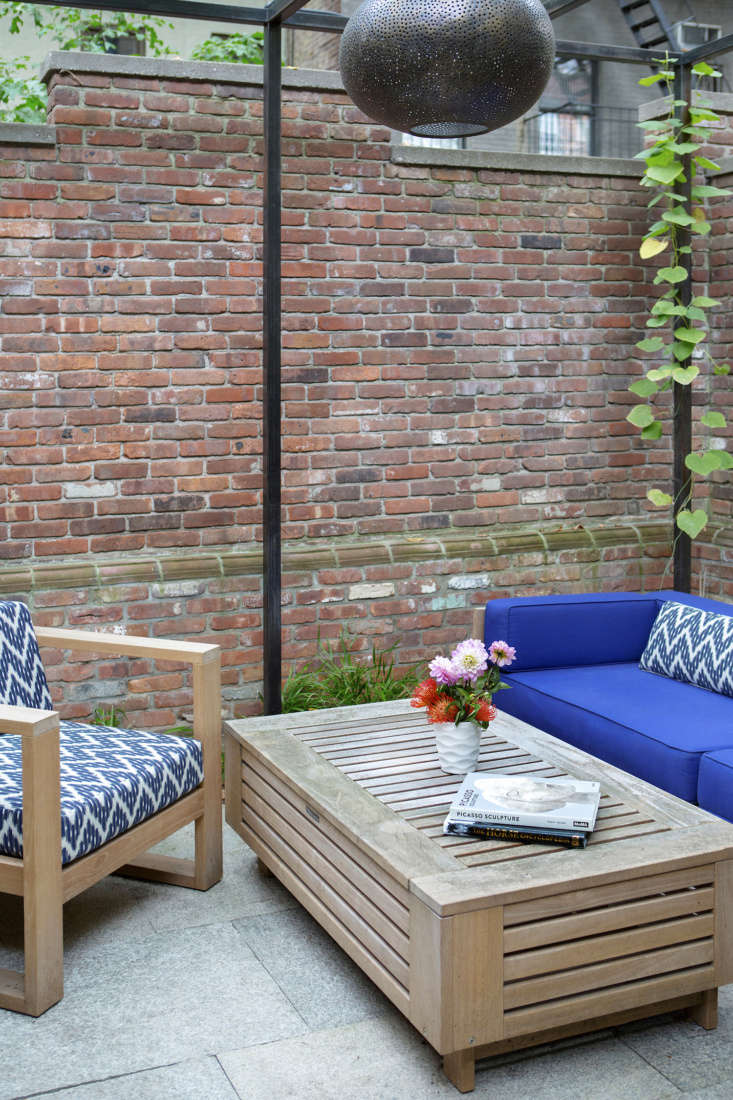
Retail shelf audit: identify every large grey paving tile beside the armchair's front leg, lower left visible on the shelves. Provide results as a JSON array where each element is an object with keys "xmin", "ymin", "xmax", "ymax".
[{"xmin": 0, "ymin": 924, "xmax": 306, "ymax": 1100}]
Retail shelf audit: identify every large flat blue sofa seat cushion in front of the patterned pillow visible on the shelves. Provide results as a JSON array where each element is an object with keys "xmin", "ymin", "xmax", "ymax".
[{"xmin": 496, "ymin": 662, "xmax": 733, "ymax": 802}]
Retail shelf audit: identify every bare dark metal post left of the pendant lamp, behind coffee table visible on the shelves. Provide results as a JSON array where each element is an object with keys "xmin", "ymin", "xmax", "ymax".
[{"xmin": 262, "ymin": 20, "xmax": 283, "ymax": 714}]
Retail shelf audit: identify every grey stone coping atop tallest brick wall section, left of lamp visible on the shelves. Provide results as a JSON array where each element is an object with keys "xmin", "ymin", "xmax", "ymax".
[{"xmin": 41, "ymin": 50, "xmax": 343, "ymax": 91}]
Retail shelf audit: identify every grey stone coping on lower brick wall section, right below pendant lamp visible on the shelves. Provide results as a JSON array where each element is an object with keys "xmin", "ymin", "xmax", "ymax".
[{"xmin": 392, "ymin": 145, "xmax": 641, "ymax": 178}]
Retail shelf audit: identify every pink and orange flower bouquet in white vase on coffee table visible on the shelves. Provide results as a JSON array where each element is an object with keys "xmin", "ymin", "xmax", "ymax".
[{"xmin": 411, "ymin": 638, "xmax": 516, "ymax": 774}]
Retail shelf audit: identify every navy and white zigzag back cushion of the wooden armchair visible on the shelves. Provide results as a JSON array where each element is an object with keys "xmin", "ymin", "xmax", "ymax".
[{"xmin": 0, "ymin": 601, "xmax": 53, "ymax": 711}]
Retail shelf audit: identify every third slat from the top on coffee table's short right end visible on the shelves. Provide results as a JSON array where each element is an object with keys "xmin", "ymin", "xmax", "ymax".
[{"xmin": 504, "ymin": 913, "xmax": 715, "ymax": 981}]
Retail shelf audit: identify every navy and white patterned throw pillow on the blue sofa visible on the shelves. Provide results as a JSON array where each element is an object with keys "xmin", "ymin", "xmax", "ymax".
[{"xmin": 639, "ymin": 600, "xmax": 733, "ymax": 695}]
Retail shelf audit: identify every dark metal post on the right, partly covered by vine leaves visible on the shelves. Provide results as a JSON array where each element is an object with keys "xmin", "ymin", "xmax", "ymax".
[{"xmin": 672, "ymin": 62, "xmax": 694, "ymax": 592}]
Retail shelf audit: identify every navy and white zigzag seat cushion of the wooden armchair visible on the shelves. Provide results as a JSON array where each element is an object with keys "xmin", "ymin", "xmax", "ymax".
[{"xmin": 0, "ymin": 722, "xmax": 204, "ymax": 864}]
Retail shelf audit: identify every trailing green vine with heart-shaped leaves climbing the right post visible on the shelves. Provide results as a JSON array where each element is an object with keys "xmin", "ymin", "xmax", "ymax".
[{"xmin": 626, "ymin": 57, "xmax": 733, "ymax": 539}]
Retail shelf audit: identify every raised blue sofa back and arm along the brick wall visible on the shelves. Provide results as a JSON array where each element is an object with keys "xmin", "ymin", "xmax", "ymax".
[{"xmin": 483, "ymin": 591, "xmax": 733, "ymax": 672}]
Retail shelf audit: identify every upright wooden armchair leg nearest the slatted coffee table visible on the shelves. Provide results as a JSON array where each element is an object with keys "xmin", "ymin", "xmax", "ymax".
[{"xmin": 194, "ymin": 652, "xmax": 222, "ymax": 890}]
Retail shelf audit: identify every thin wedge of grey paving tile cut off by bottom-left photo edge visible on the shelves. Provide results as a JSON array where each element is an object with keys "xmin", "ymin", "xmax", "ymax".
[{"xmin": 22, "ymin": 1057, "xmax": 238, "ymax": 1100}]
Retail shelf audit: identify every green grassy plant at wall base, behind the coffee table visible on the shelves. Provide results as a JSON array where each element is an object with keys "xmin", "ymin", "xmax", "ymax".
[{"xmin": 283, "ymin": 630, "xmax": 417, "ymax": 714}]
